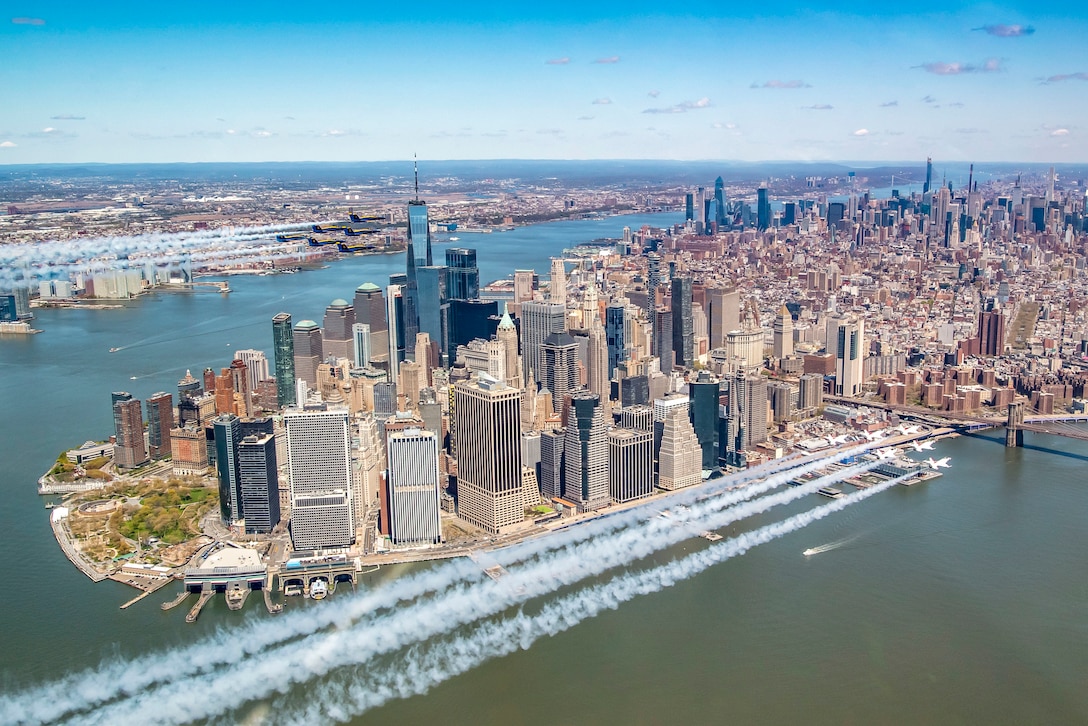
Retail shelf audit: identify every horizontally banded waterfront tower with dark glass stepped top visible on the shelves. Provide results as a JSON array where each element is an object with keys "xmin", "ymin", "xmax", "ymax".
[{"xmin": 562, "ymin": 392, "xmax": 609, "ymax": 512}]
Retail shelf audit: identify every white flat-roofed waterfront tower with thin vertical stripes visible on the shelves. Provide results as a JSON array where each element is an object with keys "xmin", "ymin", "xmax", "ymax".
[{"xmin": 386, "ymin": 428, "xmax": 442, "ymax": 544}]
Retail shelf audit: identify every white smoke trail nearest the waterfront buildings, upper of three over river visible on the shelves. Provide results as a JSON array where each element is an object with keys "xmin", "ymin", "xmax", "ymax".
[{"xmin": 0, "ymin": 446, "xmax": 873, "ymax": 722}]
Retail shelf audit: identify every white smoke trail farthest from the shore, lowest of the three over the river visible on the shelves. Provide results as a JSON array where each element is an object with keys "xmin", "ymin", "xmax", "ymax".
[{"xmin": 272, "ymin": 475, "xmax": 914, "ymax": 724}]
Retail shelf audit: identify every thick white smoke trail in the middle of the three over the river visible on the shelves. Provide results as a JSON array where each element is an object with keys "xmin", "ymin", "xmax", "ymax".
[{"xmin": 51, "ymin": 463, "xmax": 877, "ymax": 723}]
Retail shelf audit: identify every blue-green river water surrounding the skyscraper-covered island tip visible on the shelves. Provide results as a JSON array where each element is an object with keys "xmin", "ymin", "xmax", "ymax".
[{"xmin": 0, "ymin": 208, "xmax": 1088, "ymax": 725}]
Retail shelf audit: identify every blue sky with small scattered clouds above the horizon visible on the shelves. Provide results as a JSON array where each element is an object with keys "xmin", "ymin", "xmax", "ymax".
[{"xmin": 0, "ymin": 0, "xmax": 1088, "ymax": 163}]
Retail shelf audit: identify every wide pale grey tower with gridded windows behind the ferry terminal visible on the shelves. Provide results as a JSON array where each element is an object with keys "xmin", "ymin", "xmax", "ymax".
[{"xmin": 283, "ymin": 409, "xmax": 355, "ymax": 550}]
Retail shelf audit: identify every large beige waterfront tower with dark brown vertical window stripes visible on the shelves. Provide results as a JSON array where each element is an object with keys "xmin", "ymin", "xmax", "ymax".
[{"xmin": 454, "ymin": 373, "xmax": 524, "ymax": 533}]
